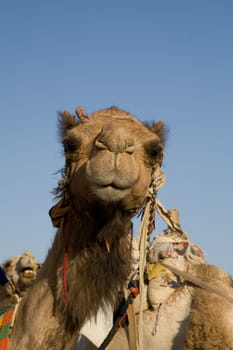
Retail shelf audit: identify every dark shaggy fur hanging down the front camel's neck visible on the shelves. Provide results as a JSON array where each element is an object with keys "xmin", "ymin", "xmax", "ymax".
[{"xmin": 55, "ymin": 208, "xmax": 131, "ymax": 332}]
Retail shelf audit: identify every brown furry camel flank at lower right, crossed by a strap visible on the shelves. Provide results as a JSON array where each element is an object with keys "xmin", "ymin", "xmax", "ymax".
[{"xmin": 185, "ymin": 264, "xmax": 233, "ymax": 350}]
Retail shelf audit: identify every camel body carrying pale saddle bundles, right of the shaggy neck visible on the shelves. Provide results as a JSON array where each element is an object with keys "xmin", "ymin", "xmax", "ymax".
[{"xmin": 107, "ymin": 210, "xmax": 233, "ymax": 350}]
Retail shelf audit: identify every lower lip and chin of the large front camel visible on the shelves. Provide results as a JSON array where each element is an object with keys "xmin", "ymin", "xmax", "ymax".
[{"xmin": 95, "ymin": 185, "xmax": 131, "ymax": 203}]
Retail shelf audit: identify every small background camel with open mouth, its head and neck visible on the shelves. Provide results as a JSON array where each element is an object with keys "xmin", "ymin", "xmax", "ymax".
[{"xmin": 0, "ymin": 251, "xmax": 40, "ymax": 309}]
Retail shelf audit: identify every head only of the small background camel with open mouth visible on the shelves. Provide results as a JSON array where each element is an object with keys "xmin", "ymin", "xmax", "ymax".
[{"xmin": 3, "ymin": 251, "xmax": 40, "ymax": 295}]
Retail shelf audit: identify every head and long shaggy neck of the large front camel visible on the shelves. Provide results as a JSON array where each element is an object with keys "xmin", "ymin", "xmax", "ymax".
[{"xmin": 10, "ymin": 107, "xmax": 165, "ymax": 350}]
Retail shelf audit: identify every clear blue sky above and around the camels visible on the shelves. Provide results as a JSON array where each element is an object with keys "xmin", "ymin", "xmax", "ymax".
[{"xmin": 0, "ymin": 0, "xmax": 233, "ymax": 274}]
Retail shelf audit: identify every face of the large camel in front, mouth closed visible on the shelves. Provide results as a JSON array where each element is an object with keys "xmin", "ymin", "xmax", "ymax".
[{"xmin": 61, "ymin": 107, "xmax": 164, "ymax": 211}]
